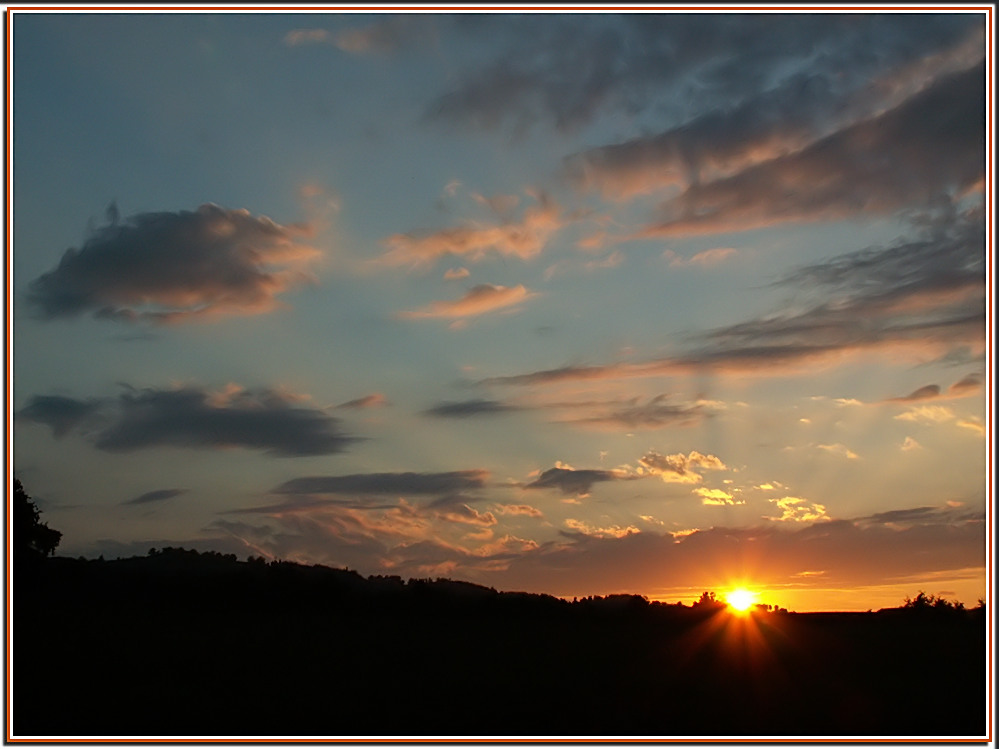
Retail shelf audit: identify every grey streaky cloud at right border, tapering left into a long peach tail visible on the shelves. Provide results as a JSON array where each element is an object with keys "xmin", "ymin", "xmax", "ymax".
[{"xmin": 480, "ymin": 202, "xmax": 985, "ymax": 388}]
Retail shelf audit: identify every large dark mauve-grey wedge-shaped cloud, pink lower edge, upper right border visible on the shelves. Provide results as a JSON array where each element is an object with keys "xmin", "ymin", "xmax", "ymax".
[{"xmin": 643, "ymin": 65, "xmax": 985, "ymax": 236}]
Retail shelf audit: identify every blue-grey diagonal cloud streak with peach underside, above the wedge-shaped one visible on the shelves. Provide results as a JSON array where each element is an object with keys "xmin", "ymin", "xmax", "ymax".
[{"xmin": 565, "ymin": 19, "xmax": 984, "ymax": 197}]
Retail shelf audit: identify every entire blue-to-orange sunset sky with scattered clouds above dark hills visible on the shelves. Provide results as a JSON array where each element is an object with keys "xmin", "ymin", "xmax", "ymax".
[{"xmin": 8, "ymin": 6, "xmax": 992, "ymax": 610}]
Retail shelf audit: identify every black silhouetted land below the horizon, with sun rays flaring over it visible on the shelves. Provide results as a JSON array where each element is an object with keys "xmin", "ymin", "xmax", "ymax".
[{"xmin": 13, "ymin": 551, "xmax": 986, "ymax": 737}]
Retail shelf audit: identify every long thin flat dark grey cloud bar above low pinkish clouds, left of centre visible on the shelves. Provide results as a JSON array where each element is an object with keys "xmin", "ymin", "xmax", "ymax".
[{"xmin": 271, "ymin": 469, "xmax": 489, "ymax": 496}]
